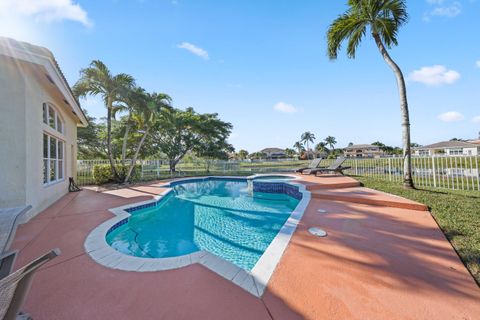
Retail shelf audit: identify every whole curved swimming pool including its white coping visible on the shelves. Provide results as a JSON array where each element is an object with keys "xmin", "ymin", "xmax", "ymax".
[{"xmin": 84, "ymin": 175, "xmax": 311, "ymax": 297}]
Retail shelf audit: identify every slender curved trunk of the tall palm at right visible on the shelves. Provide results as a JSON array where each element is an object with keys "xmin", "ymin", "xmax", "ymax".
[{"xmin": 372, "ymin": 32, "xmax": 415, "ymax": 189}]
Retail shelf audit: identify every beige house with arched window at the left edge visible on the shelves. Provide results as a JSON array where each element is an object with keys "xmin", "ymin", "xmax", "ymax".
[{"xmin": 0, "ymin": 37, "xmax": 88, "ymax": 219}]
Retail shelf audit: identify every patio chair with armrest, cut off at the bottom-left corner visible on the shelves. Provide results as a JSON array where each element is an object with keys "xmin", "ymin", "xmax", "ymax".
[{"xmin": 0, "ymin": 249, "xmax": 60, "ymax": 320}]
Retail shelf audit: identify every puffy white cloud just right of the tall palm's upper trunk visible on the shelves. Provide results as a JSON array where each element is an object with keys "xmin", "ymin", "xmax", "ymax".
[{"xmin": 408, "ymin": 65, "xmax": 460, "ymax": 86}]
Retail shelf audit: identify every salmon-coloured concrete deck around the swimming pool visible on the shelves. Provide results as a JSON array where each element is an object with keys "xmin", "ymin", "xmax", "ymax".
[{"xmin": 7, "ymin": 176, "xmax": 480, "ymax": 319}]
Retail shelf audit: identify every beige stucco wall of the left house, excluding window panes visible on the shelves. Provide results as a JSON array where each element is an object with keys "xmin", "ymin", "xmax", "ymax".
[{"xmin": 0, "ymin": 56, "xmax": 77, "ymax": 219}]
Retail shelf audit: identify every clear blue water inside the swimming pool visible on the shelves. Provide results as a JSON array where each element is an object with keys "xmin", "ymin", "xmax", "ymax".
[{"xmin": 107, "ymin": 179, "xmax": 299, "ymax": 270}]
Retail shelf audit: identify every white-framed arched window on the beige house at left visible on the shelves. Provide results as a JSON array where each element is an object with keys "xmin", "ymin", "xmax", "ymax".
[{"xmin": 43, "ymin": 103, "xmax": 65, "ymax": 185}]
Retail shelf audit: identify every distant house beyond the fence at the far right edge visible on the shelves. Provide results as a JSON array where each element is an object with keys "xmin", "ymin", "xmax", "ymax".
[{"xmin": 413, "ymin": 140, "xmax": 480, "ymax": 156}]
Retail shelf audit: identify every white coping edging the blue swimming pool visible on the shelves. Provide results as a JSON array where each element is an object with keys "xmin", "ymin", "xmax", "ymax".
[{"xmin": 84, "ymin": 174, "xmax": 311, "ymax": 297}]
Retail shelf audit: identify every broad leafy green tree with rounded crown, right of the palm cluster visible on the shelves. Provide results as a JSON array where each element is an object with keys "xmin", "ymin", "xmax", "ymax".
[{"xmin": 151, "ymin": 108, "xmax": 233, "ymax": 174}]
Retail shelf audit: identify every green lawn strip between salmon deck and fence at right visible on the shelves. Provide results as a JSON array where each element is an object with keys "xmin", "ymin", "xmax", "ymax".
[{"xmin": 355, "ymin": 176, "xmax": 480, "ymax": 285}]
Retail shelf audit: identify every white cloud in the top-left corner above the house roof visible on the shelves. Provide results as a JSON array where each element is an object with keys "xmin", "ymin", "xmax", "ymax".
[{"xmin": 0, "ymin": 0, "xmax": 92, "ymax": 27}]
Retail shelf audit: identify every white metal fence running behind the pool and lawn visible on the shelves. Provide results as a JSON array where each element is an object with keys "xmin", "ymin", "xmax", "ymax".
[{"xmin": 77, "ymin": 156, "xmax": 480, "ymax": 190}]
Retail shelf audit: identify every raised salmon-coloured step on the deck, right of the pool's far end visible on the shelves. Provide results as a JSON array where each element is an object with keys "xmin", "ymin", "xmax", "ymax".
[{"xmin": 311, "ymin": 187, "xmax": 428, "ymax": 211}]
